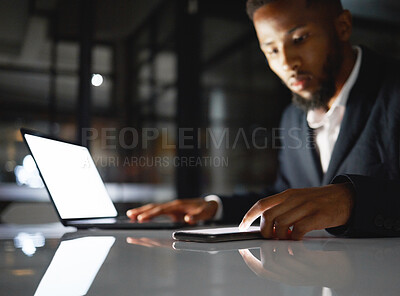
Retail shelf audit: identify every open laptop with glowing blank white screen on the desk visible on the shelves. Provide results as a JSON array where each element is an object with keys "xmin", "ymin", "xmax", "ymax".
[{"xmin": 21, "ymin": 128, "xmax": 184, "ymax": 229}]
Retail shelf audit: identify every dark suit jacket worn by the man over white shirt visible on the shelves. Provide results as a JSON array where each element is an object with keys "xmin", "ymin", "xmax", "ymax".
[{"xmin": 221, "ymin": 48, "xmax": 400, "ymax": 236}]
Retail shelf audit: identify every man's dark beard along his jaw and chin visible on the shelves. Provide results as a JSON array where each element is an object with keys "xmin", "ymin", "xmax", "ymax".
[{"xmin": 292, "ymin": 48, "xmax": 343, "ymax": 112}]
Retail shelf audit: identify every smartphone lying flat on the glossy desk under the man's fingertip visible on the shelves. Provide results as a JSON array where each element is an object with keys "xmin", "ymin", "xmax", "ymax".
[{"xmin": 172, "ymin": 226, "xmax": 262, "ymax": 243}]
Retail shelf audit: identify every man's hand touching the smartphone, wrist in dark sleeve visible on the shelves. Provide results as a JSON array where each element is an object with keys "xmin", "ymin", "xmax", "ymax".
[{"xmin": 239, "ymin": 183, "xmax": 354, "ymax": 240}]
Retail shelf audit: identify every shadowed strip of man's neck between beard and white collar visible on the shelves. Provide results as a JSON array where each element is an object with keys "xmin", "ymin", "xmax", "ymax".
[{"xmin": 328, "ymin": 44, "xmax": 357, "ymax": 110}]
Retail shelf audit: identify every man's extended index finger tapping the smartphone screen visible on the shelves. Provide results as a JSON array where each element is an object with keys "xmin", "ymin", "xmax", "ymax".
[{"xmin": 239, "ymin": 192, "xmax": 287, "ymax": 230}]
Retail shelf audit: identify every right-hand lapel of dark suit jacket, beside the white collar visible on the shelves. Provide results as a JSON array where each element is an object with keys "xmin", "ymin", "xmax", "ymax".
[{"xmin": 322, "ymin": 48, "xmax": 382, "ymax": 184}]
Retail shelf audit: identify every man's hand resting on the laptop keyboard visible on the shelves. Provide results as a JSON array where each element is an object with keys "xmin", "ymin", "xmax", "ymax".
[{"xmin": 126, "ymin": 198, "xmax": 218, "ymax": 224}]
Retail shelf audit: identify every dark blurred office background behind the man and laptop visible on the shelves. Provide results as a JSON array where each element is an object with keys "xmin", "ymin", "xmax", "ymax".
[{"xmin": 0, "ymin": 0, "xmax": 400, "ymax": 221}]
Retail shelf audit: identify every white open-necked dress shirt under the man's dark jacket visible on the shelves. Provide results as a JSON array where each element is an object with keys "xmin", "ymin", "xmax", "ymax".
[{"xmin": 307, "ymin": 46, "xmax": 362, "ymax": 173}]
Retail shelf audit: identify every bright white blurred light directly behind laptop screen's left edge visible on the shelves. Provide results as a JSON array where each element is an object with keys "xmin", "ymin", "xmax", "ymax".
[{"xmin": 14, "ymin": 155, "xmax": 44, "ymax": 188}]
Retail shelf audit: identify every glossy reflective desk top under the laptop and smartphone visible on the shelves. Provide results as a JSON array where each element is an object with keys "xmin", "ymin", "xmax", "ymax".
[{"xmin": 0, "ymin": 223, "xmax": 400, "ymax": 296}]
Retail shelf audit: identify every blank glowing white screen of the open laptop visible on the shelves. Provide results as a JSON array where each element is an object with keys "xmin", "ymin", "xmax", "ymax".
[{"xmin": 25, "ymin": 134, "xmax": 117, "ymax": 219}]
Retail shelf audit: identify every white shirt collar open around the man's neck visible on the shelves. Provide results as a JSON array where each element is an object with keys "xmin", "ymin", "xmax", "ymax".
[{"xmin": 307, "ymin": 46, "xmax": 362, "ymax": 129}]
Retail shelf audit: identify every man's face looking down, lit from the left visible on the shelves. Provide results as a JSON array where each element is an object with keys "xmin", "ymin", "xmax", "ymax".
[{"xmin": 253, "ymin": 0, "xmax": 343, "ymax": 110}]
